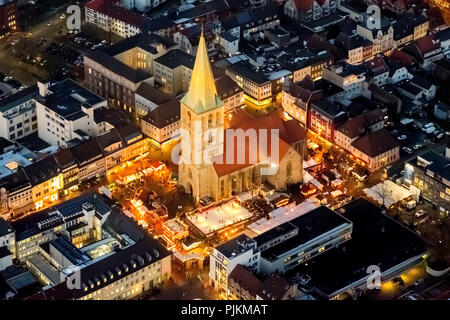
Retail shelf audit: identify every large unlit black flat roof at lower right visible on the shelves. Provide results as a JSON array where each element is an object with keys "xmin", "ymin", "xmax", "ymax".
[{"xmin": 286, "ymin": 198, "xmax": 427, "ymax": 296}]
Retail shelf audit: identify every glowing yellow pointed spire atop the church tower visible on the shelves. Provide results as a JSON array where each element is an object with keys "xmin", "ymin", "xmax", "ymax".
[{"xmin": 181, "ymin": 28, "xmax": 223, "ymax": 114}]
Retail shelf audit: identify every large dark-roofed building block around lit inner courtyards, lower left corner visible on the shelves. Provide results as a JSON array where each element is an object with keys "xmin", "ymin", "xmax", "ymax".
[{"xmin": 0, "ymin": 194, "xmax": 171, "ymax": 300}]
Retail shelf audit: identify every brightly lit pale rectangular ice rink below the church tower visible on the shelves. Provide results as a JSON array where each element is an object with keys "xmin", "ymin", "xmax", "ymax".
[{"xmin": 186, "ymin": 200, "xmax": 253, "ymax": 235}]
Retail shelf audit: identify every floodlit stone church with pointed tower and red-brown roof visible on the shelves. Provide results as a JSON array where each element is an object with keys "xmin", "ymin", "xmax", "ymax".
[{"xmin": 178, "ymin": 33, "xmax": 306, "ymax": 200}]
